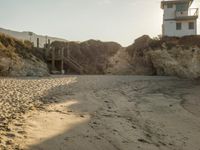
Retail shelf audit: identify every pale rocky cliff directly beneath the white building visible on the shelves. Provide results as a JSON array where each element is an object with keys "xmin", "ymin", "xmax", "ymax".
[{"xmin": 127, "ymin": 36, "xmax": 200, "ymax": 78}]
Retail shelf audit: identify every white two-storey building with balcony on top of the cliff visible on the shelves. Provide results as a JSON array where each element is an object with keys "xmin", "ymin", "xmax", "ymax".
[{"xmin": 161, "ymin": 0, "xmax": 198, "ymax": 37}]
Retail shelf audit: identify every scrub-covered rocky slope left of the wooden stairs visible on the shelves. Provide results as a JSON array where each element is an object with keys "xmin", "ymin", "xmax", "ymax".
[{"xmin": 0, "ymin": 34, "xmax": 48, "ymax": 76}]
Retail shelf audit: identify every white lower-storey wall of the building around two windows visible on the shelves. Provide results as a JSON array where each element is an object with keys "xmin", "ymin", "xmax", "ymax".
[{"xmin": 163, "ymin": 20, "xmax": 196, "ymax": 37}]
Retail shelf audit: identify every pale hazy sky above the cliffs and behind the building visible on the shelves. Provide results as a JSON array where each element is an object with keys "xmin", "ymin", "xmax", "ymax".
[{"xmin": 0, "ymin": 0, "xmax": 200, "ymax": 46}]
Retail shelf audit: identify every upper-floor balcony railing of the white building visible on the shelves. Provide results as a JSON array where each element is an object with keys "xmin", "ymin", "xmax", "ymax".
[{"xmin": 176, "ymin": 8, "xmax": 199, "ymax": 18}]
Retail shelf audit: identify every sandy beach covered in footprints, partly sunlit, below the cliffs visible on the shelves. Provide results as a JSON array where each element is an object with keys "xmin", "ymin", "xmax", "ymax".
[{"xmin": 0, "ymin": 76, "xmax": 200, "ymax": 150}]
